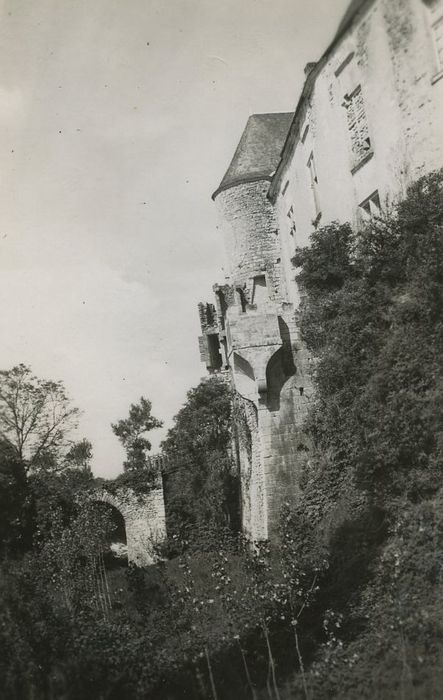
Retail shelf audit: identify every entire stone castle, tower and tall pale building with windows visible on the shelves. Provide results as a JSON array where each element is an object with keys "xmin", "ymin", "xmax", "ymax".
[{"xmin": 199, "ymin": 0, "xmax": 443, "ymax": 540}]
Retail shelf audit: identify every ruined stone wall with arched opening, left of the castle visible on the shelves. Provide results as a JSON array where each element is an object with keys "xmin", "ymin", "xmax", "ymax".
[{"xmin": 92, "ymin": 486, "xmax": 166, "ymax": 566}]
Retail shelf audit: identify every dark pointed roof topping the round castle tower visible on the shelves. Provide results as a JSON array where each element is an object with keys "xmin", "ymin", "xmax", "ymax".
[{"xmin": 212, "ymin": 112, "xmax": 294, "ymax": 199}]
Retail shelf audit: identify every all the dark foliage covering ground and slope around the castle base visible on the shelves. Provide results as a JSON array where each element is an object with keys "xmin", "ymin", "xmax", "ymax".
[{"xmin": 0, "ymin": 173, "xmax": 443, "ymax": 700}]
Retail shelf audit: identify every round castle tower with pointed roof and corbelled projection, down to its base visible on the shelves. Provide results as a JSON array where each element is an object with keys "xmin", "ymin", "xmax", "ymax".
[{"xmin": 200, "ymin": 114, "xmax": 312, "ymax": 540}]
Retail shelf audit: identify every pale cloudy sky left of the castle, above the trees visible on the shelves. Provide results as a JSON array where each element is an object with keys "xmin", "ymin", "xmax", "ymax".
[{"xmin": 0, "ymin": 0, "xmax": 348, "ymax": 478}]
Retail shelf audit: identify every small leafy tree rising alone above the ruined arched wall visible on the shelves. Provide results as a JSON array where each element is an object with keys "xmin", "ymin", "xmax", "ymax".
[{"xmin": 111, "ymin": 396, "xmax": 163, "ymax": 471}]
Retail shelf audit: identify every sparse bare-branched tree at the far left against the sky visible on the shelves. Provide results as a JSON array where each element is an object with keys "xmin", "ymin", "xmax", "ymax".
[{"xmin": 0, "ymin": 364, "xmax": 79, "ymax": 472}]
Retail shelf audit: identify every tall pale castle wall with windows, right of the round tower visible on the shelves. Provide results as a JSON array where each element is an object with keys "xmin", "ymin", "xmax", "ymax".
[{"xmin": 271, "ymin": 0, "xmax": 443, "ymax": 262}]
